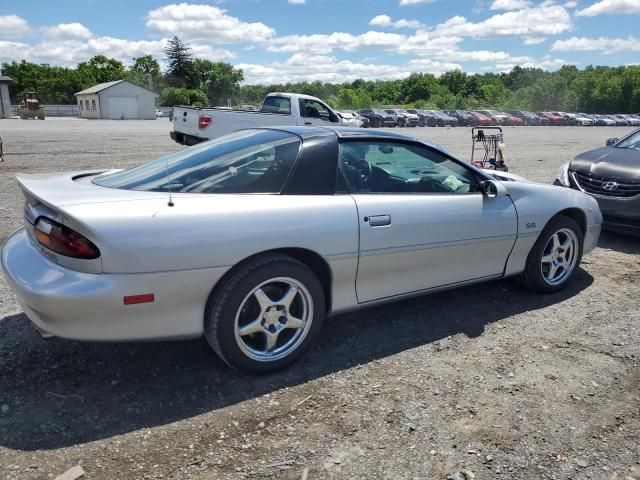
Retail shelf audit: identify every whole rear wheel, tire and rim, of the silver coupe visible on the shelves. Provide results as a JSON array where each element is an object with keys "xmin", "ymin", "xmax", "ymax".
[{"xmin": 205, "ymin": 254, "xmax": 325, "ymax": 373}]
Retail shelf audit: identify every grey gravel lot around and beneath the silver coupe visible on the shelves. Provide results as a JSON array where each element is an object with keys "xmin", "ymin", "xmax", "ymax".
[{"xmin": 0, "ymin": 118, "xmax": 640, "ymax": 480}]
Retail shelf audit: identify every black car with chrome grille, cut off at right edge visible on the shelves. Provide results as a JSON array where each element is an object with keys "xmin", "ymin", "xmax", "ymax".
[{"xmin": 554, "ymin": 126, "xmax": 640, "ymax": 235}]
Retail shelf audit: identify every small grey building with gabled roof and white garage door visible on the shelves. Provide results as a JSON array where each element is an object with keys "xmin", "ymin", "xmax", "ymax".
[{"xmin": 75, "ymin": 80, "xmax": 158, "ymax": 120}]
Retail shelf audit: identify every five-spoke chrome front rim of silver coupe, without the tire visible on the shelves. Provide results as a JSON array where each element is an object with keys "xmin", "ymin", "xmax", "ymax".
[{"xmin": 541, "ymin": 228, "xmax": 580, "ymax": 285}]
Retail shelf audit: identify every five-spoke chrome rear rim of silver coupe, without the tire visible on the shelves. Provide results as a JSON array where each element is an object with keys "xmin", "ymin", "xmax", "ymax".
[{"xmin": 234, "ymin": 277, "xmax": 313, "ymax": 362}]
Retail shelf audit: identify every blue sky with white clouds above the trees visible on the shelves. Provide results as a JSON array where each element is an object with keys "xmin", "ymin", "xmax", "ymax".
[{"xmin": 0, "ymin": 0, "xmax": 640, "ymax": 83}]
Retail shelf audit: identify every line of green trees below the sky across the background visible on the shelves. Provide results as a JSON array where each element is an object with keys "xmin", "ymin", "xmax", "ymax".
[{"xmin": 2, "ymin": 37, "xmax": 640, "ymax": 113}]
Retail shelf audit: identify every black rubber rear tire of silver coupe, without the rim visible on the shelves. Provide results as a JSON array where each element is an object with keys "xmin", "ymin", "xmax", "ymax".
[{"xmin": 204, "ymin": 254, "xmax": 325, "ymax": 374}]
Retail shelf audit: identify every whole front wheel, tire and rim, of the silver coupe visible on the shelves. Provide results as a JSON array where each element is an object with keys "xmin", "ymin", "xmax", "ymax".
[{"xmin": 519, "ymin": 215, "xmax": 584, "ymax": 293}]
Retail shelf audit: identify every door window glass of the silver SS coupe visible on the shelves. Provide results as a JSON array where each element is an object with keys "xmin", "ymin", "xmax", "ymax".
[{"xmin": 339, "ymin": 141, "xmax": 479, "ymax": 194}]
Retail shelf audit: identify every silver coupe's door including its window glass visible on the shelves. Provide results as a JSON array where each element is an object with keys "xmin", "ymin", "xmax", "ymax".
[{"xmin": 339, "ymin": 139, "xmax": 517, "ymax": 303}]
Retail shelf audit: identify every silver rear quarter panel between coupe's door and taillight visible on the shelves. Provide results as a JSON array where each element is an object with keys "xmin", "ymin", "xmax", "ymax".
[{"xmin": 65, "ymin": 194, "xmax": 358, "ymax": 307}]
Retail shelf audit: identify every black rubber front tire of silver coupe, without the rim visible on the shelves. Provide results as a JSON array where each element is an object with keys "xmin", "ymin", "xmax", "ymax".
[{"xmin": 518, "ymin": 215, "xmax": 584, "ymax": 293}]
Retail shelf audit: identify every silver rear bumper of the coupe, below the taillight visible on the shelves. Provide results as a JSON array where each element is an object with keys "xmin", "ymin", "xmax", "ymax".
[{"xmin": 0, "ymin": 229, "xmax": 227, "ymax": 341}]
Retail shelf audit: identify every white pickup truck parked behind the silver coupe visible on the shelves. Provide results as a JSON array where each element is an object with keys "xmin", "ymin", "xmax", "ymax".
[{"xmin": 170, "ymin": 92, "xmax": 353, "ymax": 145}]
